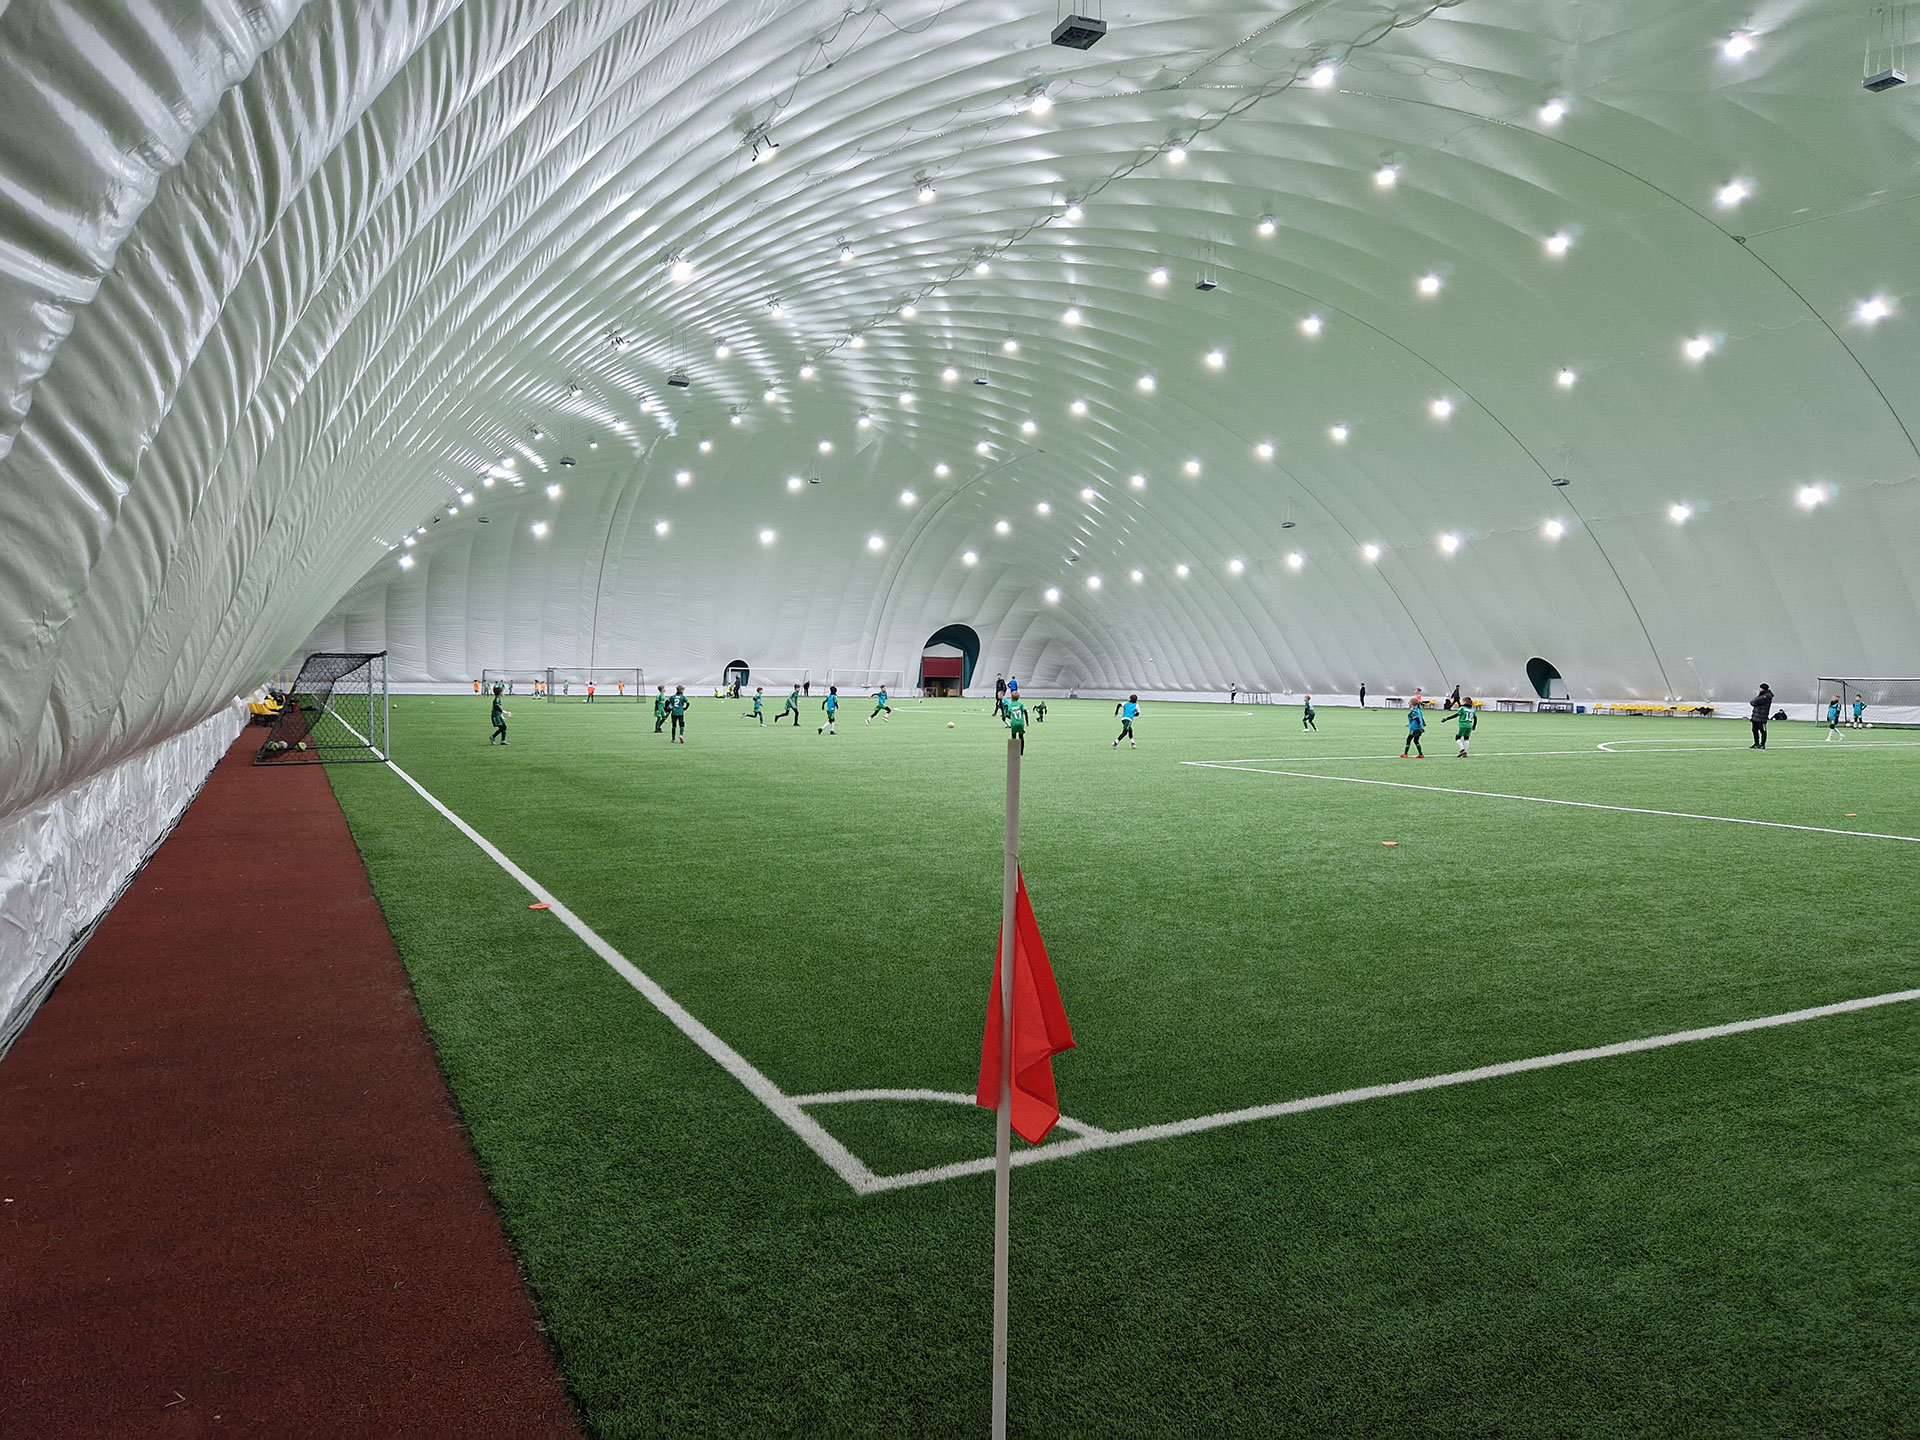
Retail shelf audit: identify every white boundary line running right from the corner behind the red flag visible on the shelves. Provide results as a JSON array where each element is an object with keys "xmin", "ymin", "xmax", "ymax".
[{"xmin": 870, "ymin": 991, "xmax": 1920, "ymax": 1190}]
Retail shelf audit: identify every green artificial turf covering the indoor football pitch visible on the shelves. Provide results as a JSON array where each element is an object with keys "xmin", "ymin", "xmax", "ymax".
[{"xmin": 330, "ymin": 697, "xmax": 1920, "ymax": 1436}]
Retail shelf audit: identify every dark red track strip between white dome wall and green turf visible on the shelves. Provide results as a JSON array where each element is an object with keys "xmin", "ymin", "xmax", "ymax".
[{"xmin": 0, "ymin": 735, "xmax": 576, "ymax": 1440}]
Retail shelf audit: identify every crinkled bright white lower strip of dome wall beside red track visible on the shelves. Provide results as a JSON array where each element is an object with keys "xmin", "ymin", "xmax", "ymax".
[{"xmin": 0, "ymin": 701, "xmax": 246, "ymax": 1056}]
